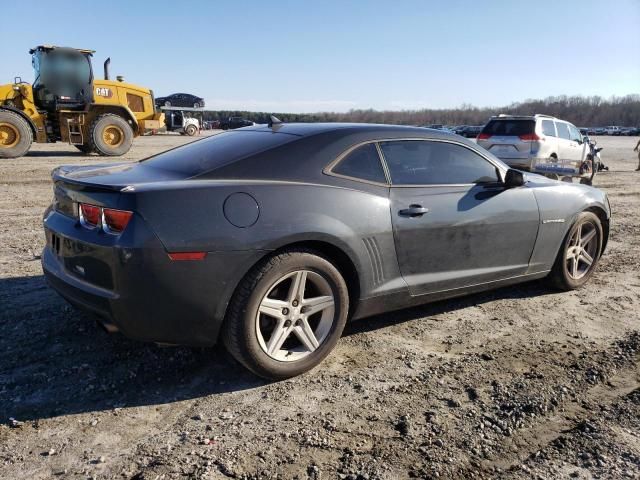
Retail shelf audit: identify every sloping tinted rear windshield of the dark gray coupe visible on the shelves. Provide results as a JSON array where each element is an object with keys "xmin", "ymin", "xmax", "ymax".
[{"xmin": 142, "ymin": 130, "xmax": 300, "ymax": 177}]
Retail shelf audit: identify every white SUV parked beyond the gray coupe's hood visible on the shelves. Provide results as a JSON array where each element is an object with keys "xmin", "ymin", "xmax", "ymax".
[{"xmin": 477, "ymin": 115, "xmax": 589, "ymax": 176}]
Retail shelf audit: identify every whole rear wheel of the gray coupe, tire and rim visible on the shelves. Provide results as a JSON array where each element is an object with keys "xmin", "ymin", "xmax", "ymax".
[{"xmin": 222, "ymin": 249, "xmax": 349, "ymax": 380}]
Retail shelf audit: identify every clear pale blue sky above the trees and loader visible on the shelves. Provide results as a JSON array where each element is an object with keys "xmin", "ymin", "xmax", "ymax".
[{"xmin": 0, "ymin": 0, "xmax": 640, "ymax": 112}]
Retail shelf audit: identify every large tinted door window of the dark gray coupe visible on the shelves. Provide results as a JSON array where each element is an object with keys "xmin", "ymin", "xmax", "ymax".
[{"xmin": 380, "ymin": 140, "xmax": 498, "ymax": 185}]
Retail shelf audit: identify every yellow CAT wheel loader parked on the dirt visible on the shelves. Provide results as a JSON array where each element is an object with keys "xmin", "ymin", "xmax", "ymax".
[{"xmin": 0, "ymin": 45, "xmax": 164, "ymax": 158}]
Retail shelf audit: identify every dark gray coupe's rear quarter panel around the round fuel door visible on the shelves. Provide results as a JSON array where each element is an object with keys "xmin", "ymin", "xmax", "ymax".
[{"xmin": 136, "ymin": 181, "xmax": 406, "ymax": 297}]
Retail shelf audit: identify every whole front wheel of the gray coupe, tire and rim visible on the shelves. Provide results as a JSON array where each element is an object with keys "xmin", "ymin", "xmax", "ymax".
[{"xmin": 549, "ymin": 212, "xmax": 603, "ymax": 290}]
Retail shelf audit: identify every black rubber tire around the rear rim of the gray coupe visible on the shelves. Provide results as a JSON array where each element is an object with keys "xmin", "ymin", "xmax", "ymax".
[{"xmin": 222, "ymin": 249, "xmax": 349, "ymax": 380}]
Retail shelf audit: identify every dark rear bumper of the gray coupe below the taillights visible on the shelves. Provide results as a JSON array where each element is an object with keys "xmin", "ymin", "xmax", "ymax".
[{"xmin": 42, "ymin": 212, "xmax": 265, "ymax": 346}]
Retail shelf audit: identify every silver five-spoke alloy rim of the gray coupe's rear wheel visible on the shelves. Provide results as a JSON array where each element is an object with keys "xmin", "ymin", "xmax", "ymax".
[{"xmin": 255, "ymin": 270, "xmax": 335, "ymax": 362}]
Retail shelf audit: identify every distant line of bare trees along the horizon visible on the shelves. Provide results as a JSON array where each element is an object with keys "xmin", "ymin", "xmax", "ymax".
[{"xmin": 204, "ymin": 95, "xmax": 640, "ymax": 127}]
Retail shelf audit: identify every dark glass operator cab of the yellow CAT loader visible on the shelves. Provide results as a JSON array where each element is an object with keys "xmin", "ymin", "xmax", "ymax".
[{"xmin": 29, "ymin": 46, "xmax": 93, "ymax": 112}]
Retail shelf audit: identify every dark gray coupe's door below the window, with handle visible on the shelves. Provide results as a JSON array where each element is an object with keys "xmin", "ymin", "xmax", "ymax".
[{"xmin": 390, "ymin": 185, "xmax": 540, "ymax": 295}]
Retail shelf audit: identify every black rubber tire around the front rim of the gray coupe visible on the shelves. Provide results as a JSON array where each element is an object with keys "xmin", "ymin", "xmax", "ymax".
[{"xmin": 548, "ymin": 212, "xmax": 603, "ymax": 290}]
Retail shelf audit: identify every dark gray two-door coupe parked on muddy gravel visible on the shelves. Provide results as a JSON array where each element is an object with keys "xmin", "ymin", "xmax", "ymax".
[{"xmin": 42, "ymin": 123, "xmax": 610, "ymax": 378}]
